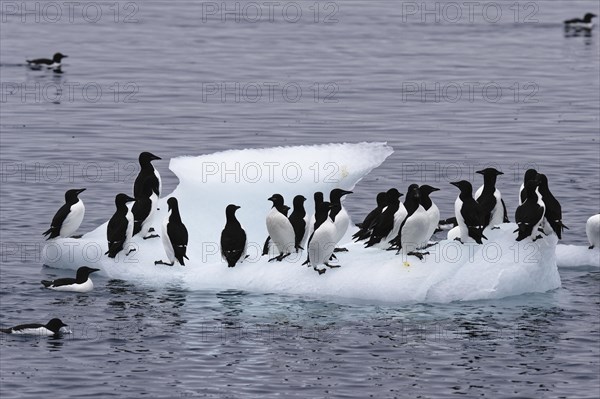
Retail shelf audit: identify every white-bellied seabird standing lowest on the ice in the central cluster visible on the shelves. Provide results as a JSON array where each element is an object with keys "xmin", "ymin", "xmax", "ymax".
[{"xmin": 305, "ymin": 201, "xmax": 340, "ymax": 274}]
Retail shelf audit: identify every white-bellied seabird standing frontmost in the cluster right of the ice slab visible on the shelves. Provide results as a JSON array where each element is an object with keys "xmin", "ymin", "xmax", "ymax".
[{"xmin": 390, "ymin": 184, "xmax": 429, "ymax": 259}]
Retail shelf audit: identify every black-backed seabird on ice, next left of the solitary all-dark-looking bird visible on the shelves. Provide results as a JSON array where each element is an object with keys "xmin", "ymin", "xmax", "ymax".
[{"xmin": 154, "ymin": 197, "xmax": 189, "ymax": 266}]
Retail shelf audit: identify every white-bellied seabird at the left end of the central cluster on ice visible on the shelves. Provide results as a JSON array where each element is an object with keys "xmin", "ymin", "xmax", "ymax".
[{"xmin": 266, "ymin": 194, "xmax": 296, "ymax": 262}]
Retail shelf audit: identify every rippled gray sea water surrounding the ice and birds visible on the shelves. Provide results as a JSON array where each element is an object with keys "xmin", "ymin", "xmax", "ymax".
[{"xmin": 0, "ymin": 0, "xmax": 600, "ymax": 399}]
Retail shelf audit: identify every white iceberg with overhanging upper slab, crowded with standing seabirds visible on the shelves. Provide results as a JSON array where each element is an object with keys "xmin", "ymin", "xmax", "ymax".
[{"xmin": 42, "ymin": 143, "xmax": 576, "ymax": 303}]
